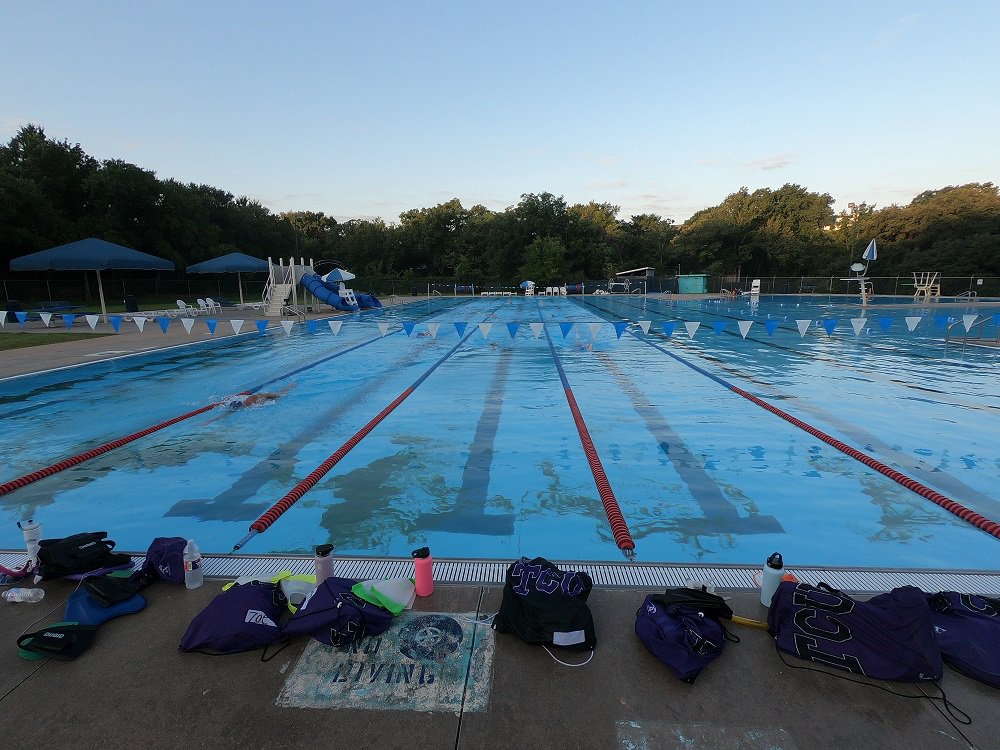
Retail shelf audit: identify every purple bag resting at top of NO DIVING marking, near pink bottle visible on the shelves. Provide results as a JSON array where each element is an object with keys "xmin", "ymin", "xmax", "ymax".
[{"xmin": 282, "ymin": 576, "xmax": 392, "ymax": 646}]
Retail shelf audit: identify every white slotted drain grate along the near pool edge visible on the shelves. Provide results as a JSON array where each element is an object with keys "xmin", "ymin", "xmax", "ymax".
[{"xmin": 0, "ymin": 551, "xmax": 1000, "ymax": 596}]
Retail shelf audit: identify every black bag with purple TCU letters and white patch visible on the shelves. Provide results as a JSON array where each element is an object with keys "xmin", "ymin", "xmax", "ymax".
[{"xmin": 493, "ymin": 557, "xmax": 597, "ymax": 651}]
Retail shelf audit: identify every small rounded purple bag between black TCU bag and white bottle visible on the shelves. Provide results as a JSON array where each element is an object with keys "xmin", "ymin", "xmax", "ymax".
[{"xmin": 635, "ymin": 588, "xmax": 739, "ymax": 684}]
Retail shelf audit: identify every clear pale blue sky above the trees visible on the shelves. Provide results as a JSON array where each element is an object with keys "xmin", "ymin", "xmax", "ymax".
[{"xmin": 0, "ymin": 0, "xmax": 1000, "ymax": 222}]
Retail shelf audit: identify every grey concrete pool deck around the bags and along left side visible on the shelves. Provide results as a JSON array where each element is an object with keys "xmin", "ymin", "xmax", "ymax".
[{"xmin": 0, "ymin": 296, "xmax": 1000, "ymax": 750}]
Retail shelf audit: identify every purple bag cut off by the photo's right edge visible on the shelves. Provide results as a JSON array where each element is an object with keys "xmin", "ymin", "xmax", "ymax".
[{"xmin": 927, "ymin": 591, "xmax": 1000, "ymax": 687}]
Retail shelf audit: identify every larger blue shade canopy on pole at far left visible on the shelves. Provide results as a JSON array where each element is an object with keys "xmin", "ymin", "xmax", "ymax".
[{"xmin": 10, "ymin": 237, "xmax": 174, "ymax": 320}]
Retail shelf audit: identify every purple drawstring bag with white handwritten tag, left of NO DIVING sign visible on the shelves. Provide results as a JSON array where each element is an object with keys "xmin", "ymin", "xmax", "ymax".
[{"xmin": 180, "ymin": 581, "xmax": 288, "ymax": 654}]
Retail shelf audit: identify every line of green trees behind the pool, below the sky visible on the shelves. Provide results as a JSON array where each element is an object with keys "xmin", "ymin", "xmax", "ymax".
[{"xmin": 0, "ymin": 125, "xmax": 1000, "ymax": 284}]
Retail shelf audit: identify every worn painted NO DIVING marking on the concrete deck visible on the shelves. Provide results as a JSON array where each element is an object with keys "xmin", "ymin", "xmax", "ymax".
[{"xmin": 275, "ymin": 612, "xmax": 495, "ymax": 715}]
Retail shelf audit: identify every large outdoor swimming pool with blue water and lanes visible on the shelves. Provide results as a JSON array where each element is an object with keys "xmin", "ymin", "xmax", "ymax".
[{"xmin": 0, "ymin": 296, "xmax": 1000, "ymax": 570}]
